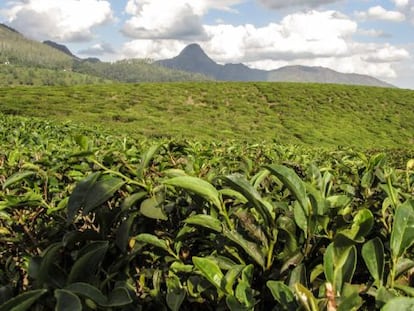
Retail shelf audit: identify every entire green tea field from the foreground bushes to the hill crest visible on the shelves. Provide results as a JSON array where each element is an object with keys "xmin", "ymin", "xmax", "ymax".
[{"xmin": 0, "ymin": 83, "xmax": 414, "ymax": 311}]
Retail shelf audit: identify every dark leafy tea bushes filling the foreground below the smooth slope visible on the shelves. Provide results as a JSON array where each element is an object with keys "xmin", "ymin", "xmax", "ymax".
[{"xmin": 0, "ymin": 113, "xmax": 414, "ymax": 311}]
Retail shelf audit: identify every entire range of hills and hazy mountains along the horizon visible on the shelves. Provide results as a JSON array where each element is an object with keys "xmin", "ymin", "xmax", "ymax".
[{"xmin": 0, "ymin": 24, "xmax": 393, "ymax": 87}]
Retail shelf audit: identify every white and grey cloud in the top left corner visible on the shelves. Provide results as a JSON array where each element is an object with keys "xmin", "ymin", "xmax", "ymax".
[{"xmin": 2, "ymin": 0, "xmax": 114, "ymax": 42}]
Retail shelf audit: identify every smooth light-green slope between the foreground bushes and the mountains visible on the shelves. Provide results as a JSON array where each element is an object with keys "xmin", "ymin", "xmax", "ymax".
[{"xmin": 0, "ymin": 82, "xmax": 414, "ymax": 149}]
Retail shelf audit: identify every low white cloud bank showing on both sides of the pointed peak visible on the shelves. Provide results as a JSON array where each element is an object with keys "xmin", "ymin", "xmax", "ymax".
[{"xmin": 123, "ymin": 10, "xmax": 410, "ymax": 78}]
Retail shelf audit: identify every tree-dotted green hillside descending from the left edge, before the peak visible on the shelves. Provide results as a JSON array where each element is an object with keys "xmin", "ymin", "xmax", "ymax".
[{"xmin": 0, "ymin": 24, "xmax": 211, "ymax": 85}]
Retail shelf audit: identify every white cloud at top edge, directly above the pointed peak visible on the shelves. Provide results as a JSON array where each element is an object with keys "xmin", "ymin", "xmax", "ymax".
[{"xmin": 123, "ymin": 0, "xmax": 241, "ymax": 40}]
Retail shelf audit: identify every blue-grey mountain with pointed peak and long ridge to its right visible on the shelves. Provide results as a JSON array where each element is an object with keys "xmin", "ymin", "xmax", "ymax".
[{"xmin": 156, "ymin": 44, "xmax": 394, "ymax": 87}]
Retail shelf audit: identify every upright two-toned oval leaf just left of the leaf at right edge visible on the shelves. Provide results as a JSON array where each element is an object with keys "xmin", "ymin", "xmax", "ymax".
[{"xmin": 361, "ymin": 237, "xmax": 385, "ymax": 288}]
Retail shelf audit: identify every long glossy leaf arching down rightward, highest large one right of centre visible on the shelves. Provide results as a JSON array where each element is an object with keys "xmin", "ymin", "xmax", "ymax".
[{"xmin": 265, "ymin": 165, "xmax": 308, "ymax": 211}]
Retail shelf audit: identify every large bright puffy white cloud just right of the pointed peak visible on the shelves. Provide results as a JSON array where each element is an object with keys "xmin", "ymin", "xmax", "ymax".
[{"xmin": 205, "ymin": 11, "xmax": 357, "ymax": 62}]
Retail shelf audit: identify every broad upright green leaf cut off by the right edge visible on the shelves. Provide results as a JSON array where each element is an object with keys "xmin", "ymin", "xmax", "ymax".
[{"xmin": 390, "ymin": 200, "xmax": 414, "ymax": 258}]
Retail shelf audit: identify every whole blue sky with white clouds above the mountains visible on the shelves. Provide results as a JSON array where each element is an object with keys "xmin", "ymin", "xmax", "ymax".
[{"xmin": 0, "ymin": 0, "xmax": 414, "ymax": 89}]
